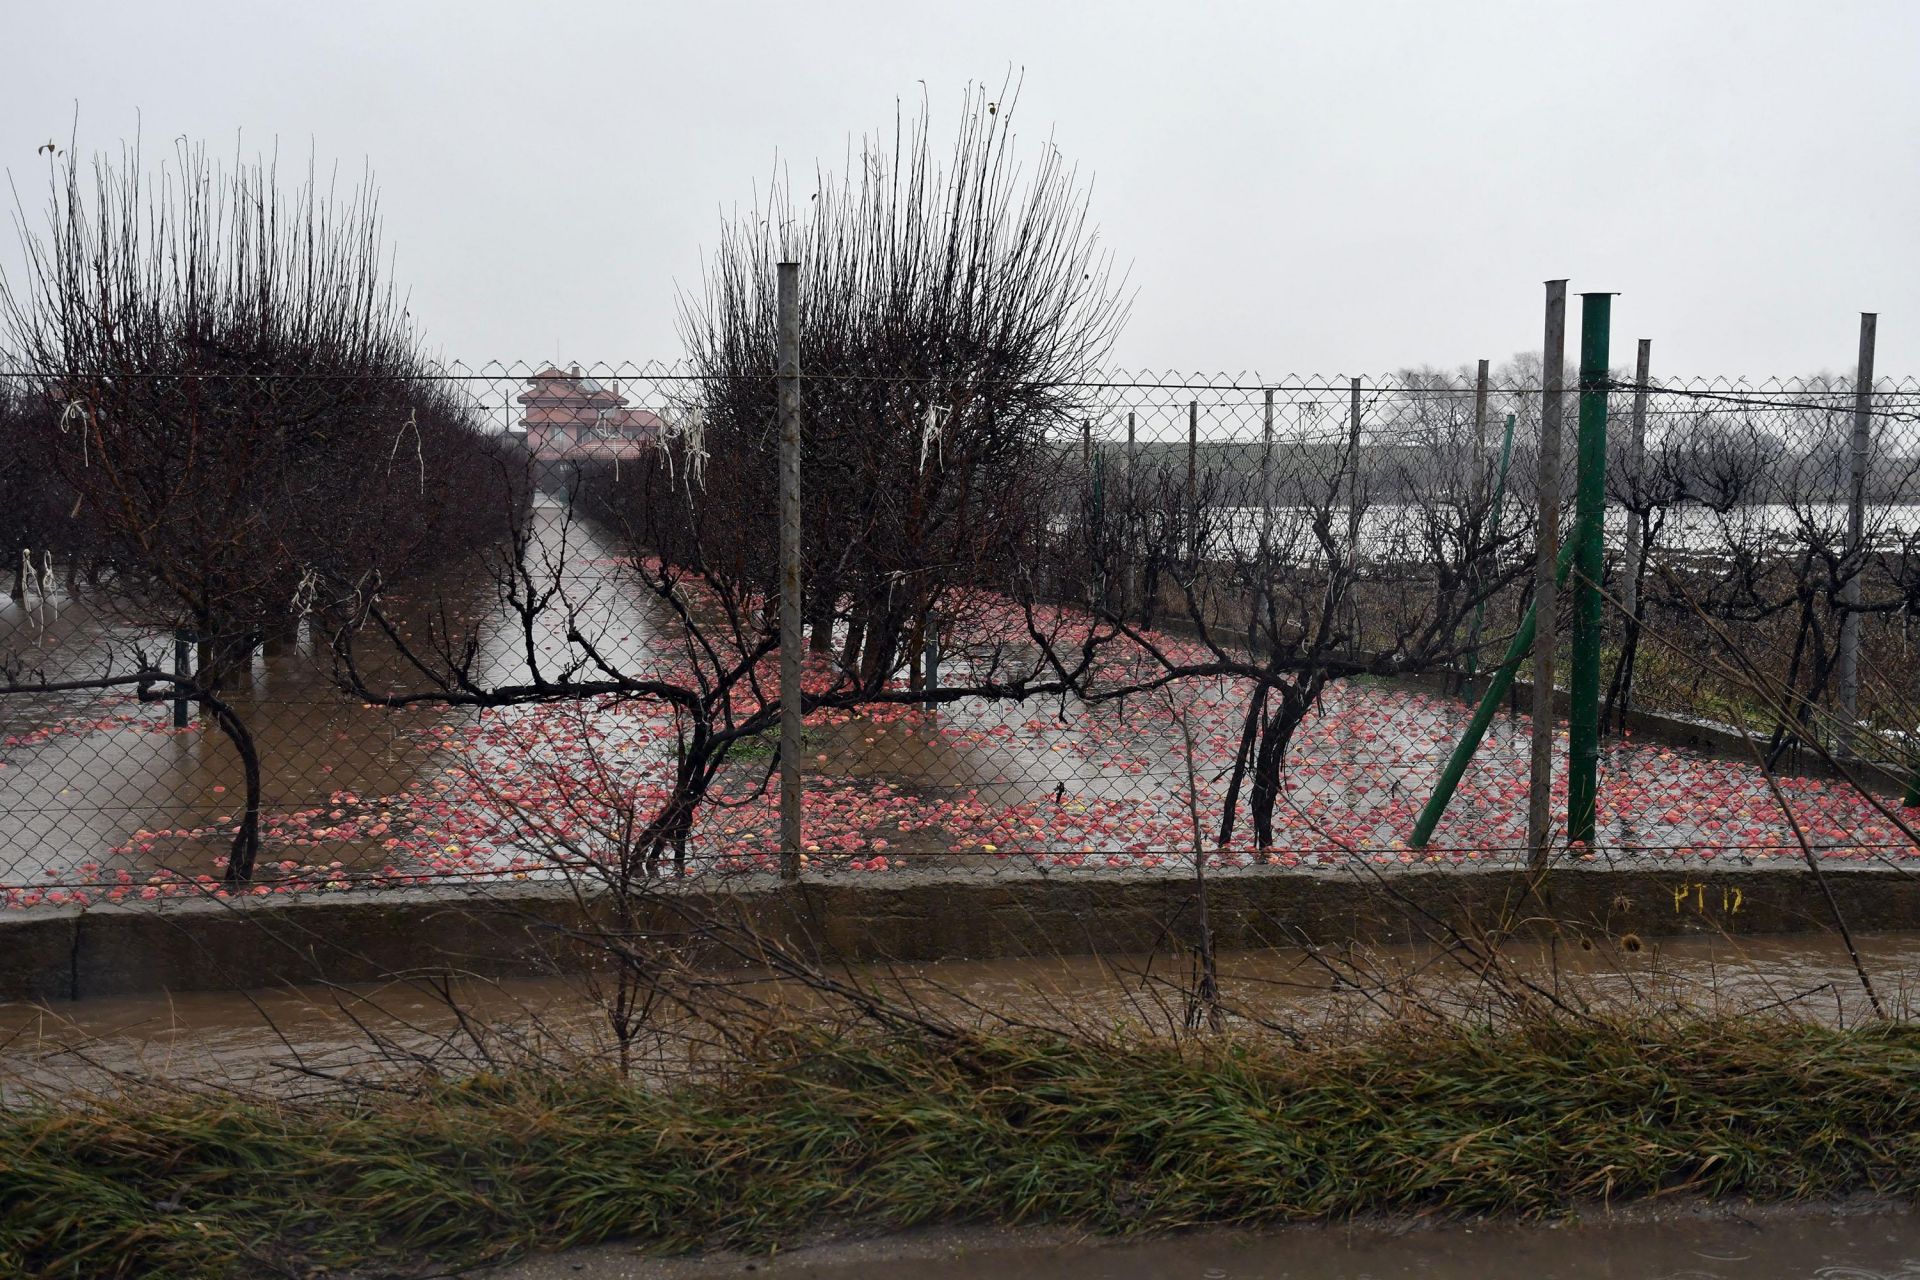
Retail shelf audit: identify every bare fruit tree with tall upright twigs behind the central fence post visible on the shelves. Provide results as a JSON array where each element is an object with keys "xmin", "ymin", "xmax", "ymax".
[{"xmin": 682, "ymin": 90, "xmax": 1125, "ymax": 685}]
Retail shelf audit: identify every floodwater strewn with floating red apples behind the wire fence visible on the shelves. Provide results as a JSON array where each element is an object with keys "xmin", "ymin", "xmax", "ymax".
[{"xmin": 0, "ymin": 506, "xmax": 1920, "ymax": 906}]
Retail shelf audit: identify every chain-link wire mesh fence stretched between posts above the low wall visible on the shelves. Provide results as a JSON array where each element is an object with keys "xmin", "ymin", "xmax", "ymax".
[{"xmin": 0, "ymin": 361, "xmax": 1920, "ymax": 908}]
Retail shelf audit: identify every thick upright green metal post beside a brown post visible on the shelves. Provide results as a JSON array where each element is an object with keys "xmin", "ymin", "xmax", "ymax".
[{"xmin": 1567, "ymin": 294, "xmax": 1613, "ymax": 848}]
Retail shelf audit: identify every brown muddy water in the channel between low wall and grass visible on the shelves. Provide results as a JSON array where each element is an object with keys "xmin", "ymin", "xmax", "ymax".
[{"xmin": 0, "ymin": 933, "xmax": 1920, "ymax": 1096}]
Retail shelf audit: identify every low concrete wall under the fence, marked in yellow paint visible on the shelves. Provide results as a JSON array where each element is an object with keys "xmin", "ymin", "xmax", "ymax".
[{"xmin": 0, "ymin": 867, "xmax": 1920, "ymax": 1000}]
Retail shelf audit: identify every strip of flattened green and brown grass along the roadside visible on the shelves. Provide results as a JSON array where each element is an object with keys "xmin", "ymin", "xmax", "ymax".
[{"xmin": 0, "ymin": 1021, "xmax": 1920, "ymax": 1276}]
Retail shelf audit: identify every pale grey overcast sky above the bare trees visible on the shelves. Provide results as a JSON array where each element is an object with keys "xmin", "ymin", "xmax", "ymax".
[{"xmin": 0, "ymin": 0, "xmax": 1920, "ymax": 376}]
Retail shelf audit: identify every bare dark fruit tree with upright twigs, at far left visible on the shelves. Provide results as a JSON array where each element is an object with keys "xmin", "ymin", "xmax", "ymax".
[{"xmin": 0, "ymin": 144, "xmax": 505, "ymax": 689}]
